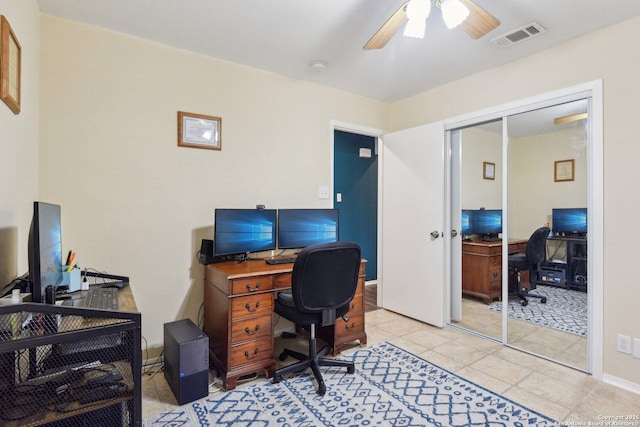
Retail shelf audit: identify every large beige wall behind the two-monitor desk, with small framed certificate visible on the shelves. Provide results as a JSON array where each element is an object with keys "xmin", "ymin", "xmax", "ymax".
[{"xmin": 40, "ymin": 16, "xmax": 387, "ymax": 347}]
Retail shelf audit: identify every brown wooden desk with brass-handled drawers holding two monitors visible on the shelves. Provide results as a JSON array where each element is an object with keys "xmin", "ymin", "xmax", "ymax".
[{"xmin": 204, "ymin": 260, "xmax": 367, "ymax": 390}]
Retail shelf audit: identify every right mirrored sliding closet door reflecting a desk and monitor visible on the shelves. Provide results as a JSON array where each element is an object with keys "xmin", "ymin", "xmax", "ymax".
[{"xmin": 501, "ymin": 100, "xmax": 589, "ymax": 370}]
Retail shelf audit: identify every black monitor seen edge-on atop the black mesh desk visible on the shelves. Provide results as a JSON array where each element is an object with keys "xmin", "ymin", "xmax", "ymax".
[{"xmin": 27, "ymin": 202, "xmax": 62, "ymax": 303}]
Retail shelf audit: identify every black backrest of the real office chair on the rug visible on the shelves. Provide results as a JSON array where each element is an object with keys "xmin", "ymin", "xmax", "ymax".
[{"xmin": 291, "ymin": 242, "xmax": 361, "ymax": 313}]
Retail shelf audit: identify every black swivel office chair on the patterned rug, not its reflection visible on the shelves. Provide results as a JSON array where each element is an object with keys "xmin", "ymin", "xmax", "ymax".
[{"xmin": 273, "ymin": 242, "xmax": 361, "ymax": 395}]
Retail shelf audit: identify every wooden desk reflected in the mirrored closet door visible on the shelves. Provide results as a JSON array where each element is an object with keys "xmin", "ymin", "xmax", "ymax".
[{"xmin": 462, "ymin": 239, "xmax": 529, "ymax": 304}]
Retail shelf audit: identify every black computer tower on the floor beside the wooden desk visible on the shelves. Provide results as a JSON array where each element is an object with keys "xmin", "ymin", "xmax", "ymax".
[{"xmin": 164, "ymin": 319, "xmax": 209, "ymax": 405}]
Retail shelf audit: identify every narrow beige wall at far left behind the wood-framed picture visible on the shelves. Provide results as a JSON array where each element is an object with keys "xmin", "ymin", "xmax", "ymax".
[{"xmin": 0, "ymin": 0, "xmax": 40, "ymax": 288}]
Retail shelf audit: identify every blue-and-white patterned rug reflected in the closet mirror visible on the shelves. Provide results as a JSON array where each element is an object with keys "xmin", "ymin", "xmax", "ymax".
[{"xmin": 489, "ymin": 285, "xmax": 587, "ymax": 337}]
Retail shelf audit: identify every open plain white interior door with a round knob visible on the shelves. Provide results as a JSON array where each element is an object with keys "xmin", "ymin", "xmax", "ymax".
[{"xmin": 381, "ymin": 122, "xmax": 448, "ymax": 327}]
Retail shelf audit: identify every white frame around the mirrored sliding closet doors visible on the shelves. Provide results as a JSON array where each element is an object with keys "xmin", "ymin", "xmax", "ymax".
[{"xmin": 444, "ymin": 80, "xmax": 604, "ymax": 380}]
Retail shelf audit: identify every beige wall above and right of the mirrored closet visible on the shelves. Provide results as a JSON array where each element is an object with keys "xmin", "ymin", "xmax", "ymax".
[{"xmin": 389, "ymin": 18, "xmax": 640, "ymax": 387}]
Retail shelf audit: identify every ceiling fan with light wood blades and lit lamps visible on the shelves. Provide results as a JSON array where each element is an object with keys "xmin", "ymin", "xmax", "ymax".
[{"xmin": 363, "ymin": 0, "xmax": 500, "ymax": 50}]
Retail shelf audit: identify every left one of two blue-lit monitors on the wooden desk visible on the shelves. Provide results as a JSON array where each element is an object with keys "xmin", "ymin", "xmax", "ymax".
[{"xmin": 213, "ymin": 209, "xmax": 276, "ymax": 256}]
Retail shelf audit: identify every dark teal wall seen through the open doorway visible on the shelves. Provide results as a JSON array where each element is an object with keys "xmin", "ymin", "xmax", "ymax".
[{"xmin": 333, "ymin": 131, "xmax": 378, "ymax": 280}]
